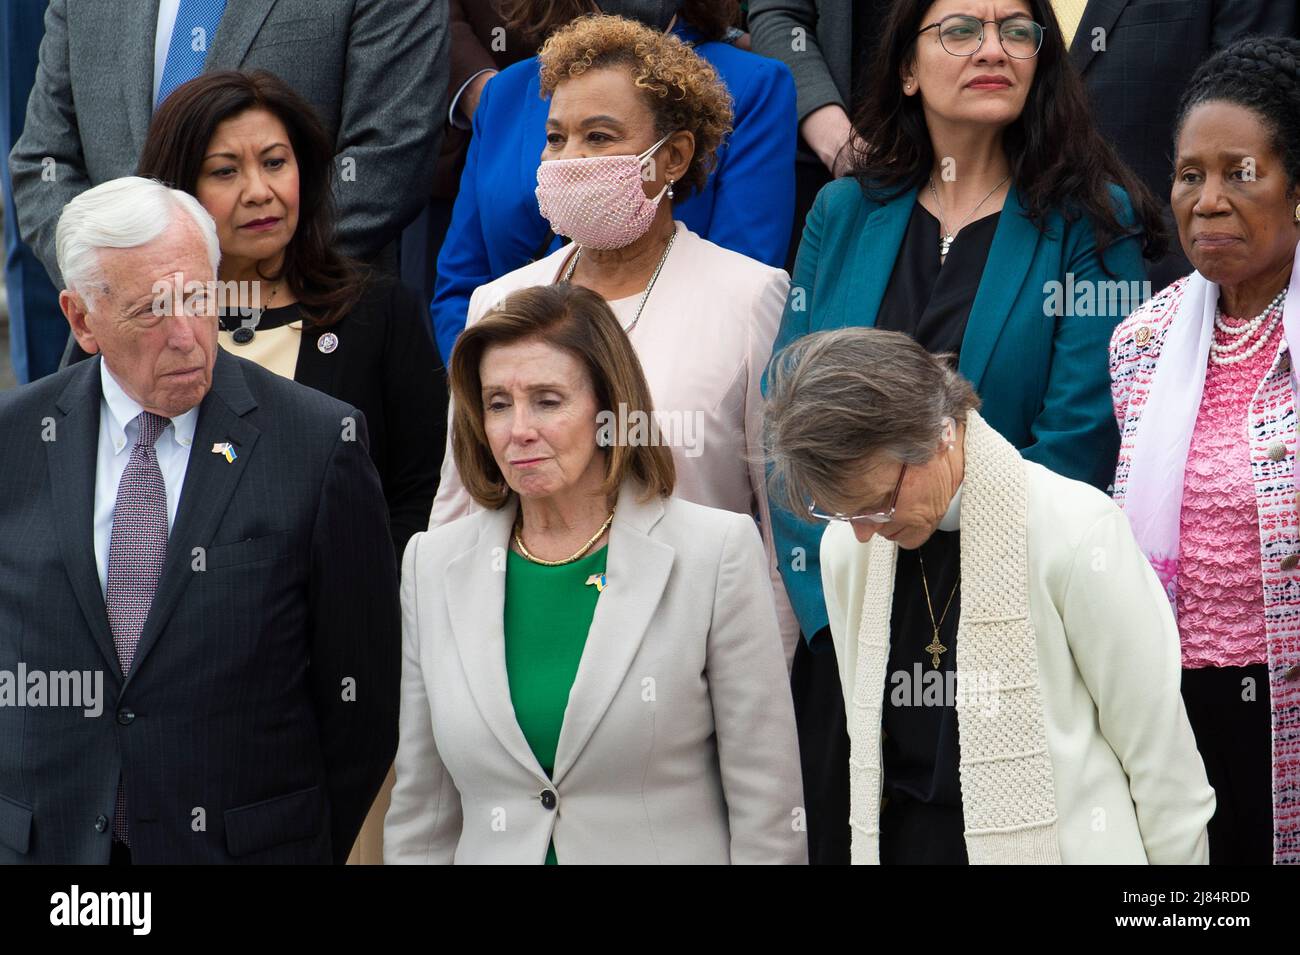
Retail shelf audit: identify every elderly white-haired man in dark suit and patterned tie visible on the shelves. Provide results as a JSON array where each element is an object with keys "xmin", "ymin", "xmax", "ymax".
[{"xmin": 0, "ymin": 177, "xmax": 400, "ymax": 864}]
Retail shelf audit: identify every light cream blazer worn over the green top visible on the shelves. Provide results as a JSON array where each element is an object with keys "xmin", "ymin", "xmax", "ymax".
[{"xmin": 384, "ymin": 487, "xmax": 807, "ymax": 864}]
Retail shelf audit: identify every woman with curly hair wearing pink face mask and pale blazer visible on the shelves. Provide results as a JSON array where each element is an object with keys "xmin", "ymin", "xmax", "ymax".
[{"xmin": 430, "ymin": 17, "xmax": 797, "ymax": 660}]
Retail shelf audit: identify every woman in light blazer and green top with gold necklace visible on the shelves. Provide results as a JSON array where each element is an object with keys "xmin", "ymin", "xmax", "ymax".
[{"xmin": 384, "ymin": 283, "xmax": 807, "ymax": 865}]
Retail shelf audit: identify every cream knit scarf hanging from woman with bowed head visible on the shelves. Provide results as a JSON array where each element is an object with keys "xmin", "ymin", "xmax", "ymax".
[{"xmin": 849, "ymin": 412, "xmax": 1061, "ymax": 864}]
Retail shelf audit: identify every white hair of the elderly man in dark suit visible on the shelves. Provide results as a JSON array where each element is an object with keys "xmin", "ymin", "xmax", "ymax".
[{"xmin": 55, "ymin": 175, "xmax": 221, "ymax": 298}]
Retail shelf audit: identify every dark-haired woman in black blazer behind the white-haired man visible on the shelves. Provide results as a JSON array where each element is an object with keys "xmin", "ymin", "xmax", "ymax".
[{"xmin": 138, "ymin": 70, "xmax": 447, "ymax": 561}]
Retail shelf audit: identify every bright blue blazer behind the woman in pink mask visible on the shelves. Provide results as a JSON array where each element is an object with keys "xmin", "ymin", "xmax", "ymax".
[{"xmin": 429, "ymin": 25, "xmax": 798, "ymax": 361}]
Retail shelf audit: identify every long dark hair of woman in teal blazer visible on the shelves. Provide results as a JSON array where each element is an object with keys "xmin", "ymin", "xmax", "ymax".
[{"xmin": 853, "ymin": 0, "xmax": 1169, "ymax": 259}]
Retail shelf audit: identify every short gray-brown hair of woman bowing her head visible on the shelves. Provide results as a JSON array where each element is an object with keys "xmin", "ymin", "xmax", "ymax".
[{"xmin": 763, "ymin": 327, "xmax": 980, "ymax": 520}]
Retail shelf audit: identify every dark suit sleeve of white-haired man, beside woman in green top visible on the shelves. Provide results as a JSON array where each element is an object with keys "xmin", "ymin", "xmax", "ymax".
[{"xmin": 308, "ymin": 409, "xmax": 402, "ymax": 863}]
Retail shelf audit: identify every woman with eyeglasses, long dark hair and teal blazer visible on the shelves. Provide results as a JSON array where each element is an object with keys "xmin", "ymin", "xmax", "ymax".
[{"xmin": 774, "ymin": 0, "xmax": 1164, "ymax": 856}]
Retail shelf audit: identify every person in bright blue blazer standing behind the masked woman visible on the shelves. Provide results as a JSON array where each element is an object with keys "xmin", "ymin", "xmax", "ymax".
[{"xmin": 429, "ymin": 0, "xmax": 798, "ymax": 363}]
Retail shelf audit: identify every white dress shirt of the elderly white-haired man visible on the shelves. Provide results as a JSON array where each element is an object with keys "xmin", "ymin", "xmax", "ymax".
[{"xmin": 95, "ymin": 357, "xmax": 199, "ymax": 598}]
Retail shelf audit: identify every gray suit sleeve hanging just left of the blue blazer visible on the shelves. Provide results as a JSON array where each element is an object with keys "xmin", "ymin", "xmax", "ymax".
[{"xmin": 335, "ymin": 0, "xmax": 449, "ymax": 259}]
